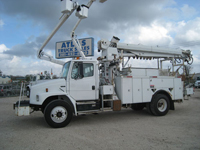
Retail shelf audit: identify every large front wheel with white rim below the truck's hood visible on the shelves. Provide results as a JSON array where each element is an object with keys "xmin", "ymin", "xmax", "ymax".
[{"xmin": 44, "ymin": 100, "xmax": 73, "ymax": 128}]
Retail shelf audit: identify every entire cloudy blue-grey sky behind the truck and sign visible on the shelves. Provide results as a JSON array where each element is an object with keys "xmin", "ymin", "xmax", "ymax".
[{"xmin": 0, "ymin": 0, "xmax": 200, "ymax": 76}]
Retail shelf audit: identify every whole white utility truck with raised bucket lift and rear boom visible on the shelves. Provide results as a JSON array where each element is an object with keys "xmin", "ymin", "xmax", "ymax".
[{"xmin": 14, "ymin": 0, "xmax": 193, "ymax": 128}]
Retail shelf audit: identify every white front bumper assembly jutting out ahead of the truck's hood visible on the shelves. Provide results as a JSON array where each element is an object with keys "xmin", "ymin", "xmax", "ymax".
[{"xmin": 13, "ymin": 100, "xmax": 31, "ymax": 116}]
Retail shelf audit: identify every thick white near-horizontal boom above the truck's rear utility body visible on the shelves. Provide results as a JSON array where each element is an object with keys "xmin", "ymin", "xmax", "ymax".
[{"xmin": 98, "ymin": 37, "xmax": 193, "ymax": 65}]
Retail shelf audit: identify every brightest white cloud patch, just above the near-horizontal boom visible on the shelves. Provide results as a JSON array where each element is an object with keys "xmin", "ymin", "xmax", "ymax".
[{"xmin": 119, "ymin": 21, "xmax": 173, "ymax": 46}]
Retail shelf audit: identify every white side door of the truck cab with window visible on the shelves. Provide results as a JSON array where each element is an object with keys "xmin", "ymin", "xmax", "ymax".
[{"xmin": 69, "ymin": 62, "xmax": 98, "ymax": 100}]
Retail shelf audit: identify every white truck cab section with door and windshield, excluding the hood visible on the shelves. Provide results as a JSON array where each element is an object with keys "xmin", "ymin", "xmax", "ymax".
[{"xmin": 61, "ymin": 60, "xmax": 99, "ymax": 101}]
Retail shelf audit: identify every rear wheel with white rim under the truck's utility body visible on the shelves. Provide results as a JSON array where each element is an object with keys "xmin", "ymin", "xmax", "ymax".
[{"xmin": 150, "ymin": 94, "xmax": 170, "ymax": 116}]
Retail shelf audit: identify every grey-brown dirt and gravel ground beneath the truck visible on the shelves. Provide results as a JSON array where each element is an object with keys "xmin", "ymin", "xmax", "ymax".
[{"xmin": 0, "ymin": 89, "xmax": 200, "ymax": 150}]
